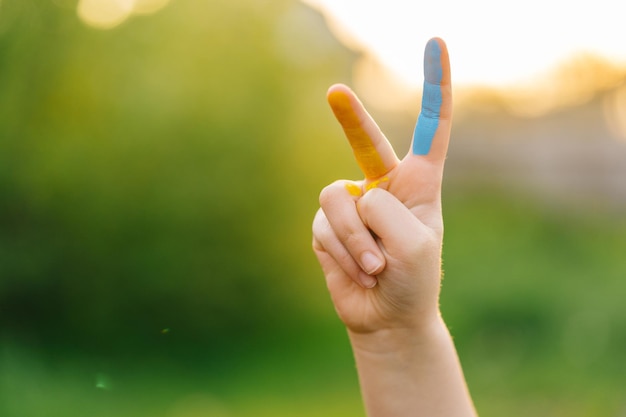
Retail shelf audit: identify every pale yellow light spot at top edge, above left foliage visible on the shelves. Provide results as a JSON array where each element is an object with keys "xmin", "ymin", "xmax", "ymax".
[{"xmin": 76, "ymin": 0, "xmax": 169, "ymax": 29}]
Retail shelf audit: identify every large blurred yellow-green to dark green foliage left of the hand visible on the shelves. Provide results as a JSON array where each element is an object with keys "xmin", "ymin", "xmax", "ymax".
[{"xmin": 0, "ymin": 0, "xmax": 353, "ymax": 353}]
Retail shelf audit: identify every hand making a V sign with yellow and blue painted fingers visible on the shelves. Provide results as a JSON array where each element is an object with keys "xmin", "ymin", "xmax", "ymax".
[{"xmin": 313, "ymin": 39, "xmax": 452, "ymax": 333}]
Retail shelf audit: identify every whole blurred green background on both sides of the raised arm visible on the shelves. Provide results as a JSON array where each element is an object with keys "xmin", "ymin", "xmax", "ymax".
[{"xmin": 0, "ymin": 0, "xmax": 626, "ymax": 417}]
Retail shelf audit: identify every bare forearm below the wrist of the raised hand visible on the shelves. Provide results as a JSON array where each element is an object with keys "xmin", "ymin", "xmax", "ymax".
[{"xmin": 349, "ymin": 320, "xmax": 476, "ymax": 417}]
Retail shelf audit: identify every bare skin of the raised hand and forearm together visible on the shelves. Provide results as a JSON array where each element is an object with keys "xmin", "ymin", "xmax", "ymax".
[{"xmin": 313, "ymin": 39, "xmax": 476, "ymax": 417}]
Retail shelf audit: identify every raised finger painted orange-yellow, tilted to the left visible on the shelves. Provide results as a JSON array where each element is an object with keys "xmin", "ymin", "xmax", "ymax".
[{"xmin": 327, "ymin": 84, "xmax": 399, "ymax": 180}]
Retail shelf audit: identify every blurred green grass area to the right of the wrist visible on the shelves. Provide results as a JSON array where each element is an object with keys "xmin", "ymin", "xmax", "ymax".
[{"xmin": 442, "ymin": 187, "xmax": 626, "ymax": 416}]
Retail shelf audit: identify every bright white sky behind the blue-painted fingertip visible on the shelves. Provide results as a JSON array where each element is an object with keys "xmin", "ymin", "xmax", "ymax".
[{"xmin": 303, "ymin": 0, "xmax": 626, "ymax": 87}]
